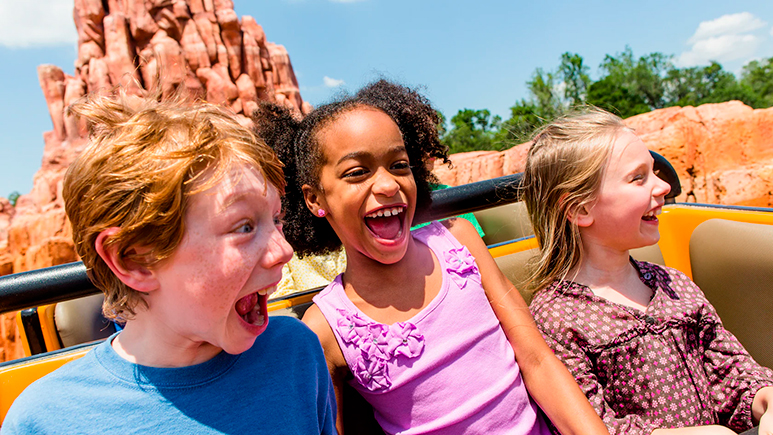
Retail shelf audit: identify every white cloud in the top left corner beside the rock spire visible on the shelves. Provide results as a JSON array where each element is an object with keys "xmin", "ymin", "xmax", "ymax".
[{"xmin": 0, "ymin": 0, "xmax": 78, "ymax": 48}]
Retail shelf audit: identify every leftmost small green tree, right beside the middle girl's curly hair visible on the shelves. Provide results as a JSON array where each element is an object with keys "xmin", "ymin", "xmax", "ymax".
[{"xmin": 441, "ymin": 109, "xmax": 502, "ymax": 153}]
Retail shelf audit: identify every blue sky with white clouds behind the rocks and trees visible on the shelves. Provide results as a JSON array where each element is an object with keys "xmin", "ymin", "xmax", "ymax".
[{"xmin": 0, "ymin": 0, "xmax": 773, "ymax": 196}]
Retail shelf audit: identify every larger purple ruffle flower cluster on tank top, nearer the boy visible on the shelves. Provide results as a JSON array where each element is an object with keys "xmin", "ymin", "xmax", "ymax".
[{"xmin": 337, "ymin": 308, "xmax": 424, "ymax": 391}]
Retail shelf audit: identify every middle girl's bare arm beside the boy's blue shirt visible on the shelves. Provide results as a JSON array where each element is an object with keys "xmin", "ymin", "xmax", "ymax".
[{"xmin": 302, "ymin": 305, "xmax": 349, "ymax": 435}]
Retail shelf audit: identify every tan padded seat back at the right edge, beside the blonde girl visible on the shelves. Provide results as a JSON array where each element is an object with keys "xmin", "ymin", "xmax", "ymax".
[{"xmin": 690, "ymin": 219, "xmax": 773, "ymax": 367}]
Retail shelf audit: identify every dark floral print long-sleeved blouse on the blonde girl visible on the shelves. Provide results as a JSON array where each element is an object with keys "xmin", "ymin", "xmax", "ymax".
[{"xmin": 530, "ymin": 260, "xmax": 773, "ymax": 434}]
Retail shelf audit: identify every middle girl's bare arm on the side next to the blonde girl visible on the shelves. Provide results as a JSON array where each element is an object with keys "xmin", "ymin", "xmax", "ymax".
[{"xmin": 443, "ymin": 219, "xmax": 608, "ymax": 435}]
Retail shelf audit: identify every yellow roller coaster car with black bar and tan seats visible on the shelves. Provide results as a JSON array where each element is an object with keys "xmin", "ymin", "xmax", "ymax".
[{"xmin": 0, "ymin": 153, "xmax": 773, "ymax": 433}]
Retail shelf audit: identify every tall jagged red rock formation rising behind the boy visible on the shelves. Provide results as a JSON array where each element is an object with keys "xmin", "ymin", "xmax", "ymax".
[{"xmin": 0, "ymin": 0, "xmax": 311, "ymax": 361}]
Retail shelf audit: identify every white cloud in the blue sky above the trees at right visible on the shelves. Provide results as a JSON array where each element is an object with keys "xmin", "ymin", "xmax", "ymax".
[{"xmin": 675, "ymin": 12, "xmax": 767, "ymax": 67}]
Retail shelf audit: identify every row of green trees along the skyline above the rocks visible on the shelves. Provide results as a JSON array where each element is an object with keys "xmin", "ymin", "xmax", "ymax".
[{"xmin": 441, "ymin": 47, "xmax": 773, "ymax": 153}]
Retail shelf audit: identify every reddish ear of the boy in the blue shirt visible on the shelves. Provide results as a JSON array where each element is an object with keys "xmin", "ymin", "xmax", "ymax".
[{"xmin": 94, "ymin": 227, "xmax": 158, "ymax": 293}]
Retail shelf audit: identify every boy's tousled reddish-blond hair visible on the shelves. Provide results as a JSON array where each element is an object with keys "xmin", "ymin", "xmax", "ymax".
[{"xmin": 63, "ymin": 93, "xmax": 285, "ymax": 320}]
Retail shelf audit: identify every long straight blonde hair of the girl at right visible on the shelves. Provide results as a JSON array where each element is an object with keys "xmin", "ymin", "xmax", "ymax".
[{"xmin": 523, "ymin": 107, "xmax": 628, "ymax": 292}]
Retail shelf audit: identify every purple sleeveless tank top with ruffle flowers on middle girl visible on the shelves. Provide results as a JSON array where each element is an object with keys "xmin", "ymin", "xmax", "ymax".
[{"xmin": 314, "ymin": 222, "xmax": 550, "ymax": 434}]
